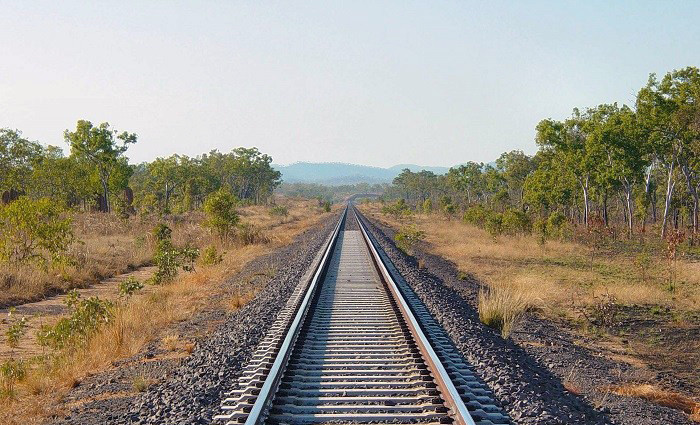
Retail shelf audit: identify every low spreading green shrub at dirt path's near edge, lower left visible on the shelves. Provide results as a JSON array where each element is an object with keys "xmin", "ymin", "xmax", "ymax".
[{"xmin": 37, "ymin": 290, "xmax": 114, "ymax": 350}]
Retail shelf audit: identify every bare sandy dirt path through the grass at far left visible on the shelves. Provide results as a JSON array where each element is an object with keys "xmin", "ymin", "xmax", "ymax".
[{"xmin": 0, "ymin": 266, "xmax": 155, "ymax": 361}]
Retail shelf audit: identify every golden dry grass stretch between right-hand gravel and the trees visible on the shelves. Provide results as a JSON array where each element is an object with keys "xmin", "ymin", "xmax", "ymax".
[{"xmin": 360, "ymin": 203, "xmax": 700, "ymax": 318}]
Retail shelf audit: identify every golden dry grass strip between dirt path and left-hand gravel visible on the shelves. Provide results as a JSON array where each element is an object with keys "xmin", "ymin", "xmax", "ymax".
[{"xmin": 0, "ymin": 195, "xmax": 340, "ymax": 424}]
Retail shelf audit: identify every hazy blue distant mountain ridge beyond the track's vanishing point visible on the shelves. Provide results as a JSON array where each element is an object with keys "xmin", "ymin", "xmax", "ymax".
[{"xmin": 273, "ymin": 162, "xmax": 450, "ymax": 185}]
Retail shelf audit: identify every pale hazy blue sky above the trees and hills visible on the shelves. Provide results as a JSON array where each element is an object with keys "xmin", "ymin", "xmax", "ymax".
[{"xmin": 0, "ymin": 0, "xmax": 700, "ymax": 166}]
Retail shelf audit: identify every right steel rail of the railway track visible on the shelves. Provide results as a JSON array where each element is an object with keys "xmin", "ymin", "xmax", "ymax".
[{"xmin": 352, "ymin": 207, "xmax": 476, "ymax": 425}]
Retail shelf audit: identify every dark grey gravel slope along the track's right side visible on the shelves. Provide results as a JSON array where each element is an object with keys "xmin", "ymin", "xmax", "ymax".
[{"xmin": 358, "ymin": 210, "xmax": 692, "ymax": 425}]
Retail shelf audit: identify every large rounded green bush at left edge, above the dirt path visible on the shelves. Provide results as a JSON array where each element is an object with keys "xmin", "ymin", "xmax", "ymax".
[{"xmin": 0, "ymin": 197, "xmax": 75, "ymax": 266}]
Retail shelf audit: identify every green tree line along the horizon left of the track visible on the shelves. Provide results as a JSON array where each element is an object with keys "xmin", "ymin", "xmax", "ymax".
[{"xmin": 0, "ymin": 120, "xmax": 281, "ymax": 213}]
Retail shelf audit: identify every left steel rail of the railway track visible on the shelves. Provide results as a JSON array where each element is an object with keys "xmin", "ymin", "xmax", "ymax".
[{"xmin": 245, "ymin": 206, "xmax": 348, "ymax": 425}]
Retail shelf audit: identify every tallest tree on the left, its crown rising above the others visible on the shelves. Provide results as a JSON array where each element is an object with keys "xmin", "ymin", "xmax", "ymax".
[{"xmin": 64, "ymin": 120, "xmax": 137, "ymax": 212}]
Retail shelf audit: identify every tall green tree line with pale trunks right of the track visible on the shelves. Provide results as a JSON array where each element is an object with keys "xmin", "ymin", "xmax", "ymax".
[{"xmin": 385, "ymin": 67, "xmax": 700, "ymax": 237}]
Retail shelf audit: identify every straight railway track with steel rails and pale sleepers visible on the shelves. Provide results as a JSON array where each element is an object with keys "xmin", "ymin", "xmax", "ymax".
[{"xmin": 216, "ymin": 206, "xmax": 510, "ymax": 425}]
